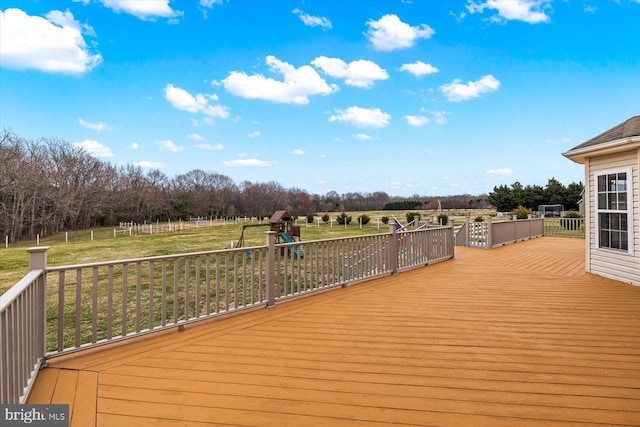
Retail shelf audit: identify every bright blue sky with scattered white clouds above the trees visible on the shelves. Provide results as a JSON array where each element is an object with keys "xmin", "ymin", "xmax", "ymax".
[{"xmin": 0, "ymin": 0, "xmax": 640, "ymax": 196}]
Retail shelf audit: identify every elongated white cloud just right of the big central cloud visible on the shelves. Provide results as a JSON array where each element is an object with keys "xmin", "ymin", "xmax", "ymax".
[{"xmin": 311, "ymin": 56, "xmax": 389, "ymax": 89}]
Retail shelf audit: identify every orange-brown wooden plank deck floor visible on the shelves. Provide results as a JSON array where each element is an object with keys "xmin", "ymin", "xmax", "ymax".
[{"xmin": 30, "ymin": 237, "xmax": 640, "ymax": 427}]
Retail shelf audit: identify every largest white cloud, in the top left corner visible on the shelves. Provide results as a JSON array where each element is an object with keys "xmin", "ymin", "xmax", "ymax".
[{"xmin": 0, "ymin": 9, "xmax": 102, "ymax": 74}]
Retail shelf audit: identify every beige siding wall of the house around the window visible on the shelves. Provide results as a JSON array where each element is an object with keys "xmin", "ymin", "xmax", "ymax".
[{"xmin": 585, "ymin": 150, "xmax": 640, "ymax": 286}]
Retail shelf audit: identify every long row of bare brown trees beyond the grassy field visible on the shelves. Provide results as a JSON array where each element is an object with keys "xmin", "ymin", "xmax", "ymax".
[{"xmin": 0, "ymin": 130, "xmax": 487, "ymax": 242}]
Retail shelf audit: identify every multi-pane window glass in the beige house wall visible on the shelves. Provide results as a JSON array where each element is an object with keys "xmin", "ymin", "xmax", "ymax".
[{"xmin": 597, "ymin": 169, "xmax": 632, "ymax": 253}]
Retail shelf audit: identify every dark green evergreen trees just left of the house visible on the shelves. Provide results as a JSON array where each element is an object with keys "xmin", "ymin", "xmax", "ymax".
[{"xmin": 487, "ymin": 178, "xmax": 584, "ymax": 212}]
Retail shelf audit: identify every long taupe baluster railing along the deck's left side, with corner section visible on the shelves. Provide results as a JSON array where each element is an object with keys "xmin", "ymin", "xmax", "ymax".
[{"xmin": 0, "ymin": 226, "xmax": 454, "ymax": 403}]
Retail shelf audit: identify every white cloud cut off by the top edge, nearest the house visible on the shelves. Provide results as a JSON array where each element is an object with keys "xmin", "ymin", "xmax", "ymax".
[{"xmin": 466, "ymin": 0, "xmax": 551, "ymax": 24}]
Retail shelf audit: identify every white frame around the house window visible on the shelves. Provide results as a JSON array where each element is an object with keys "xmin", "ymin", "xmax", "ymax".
[{"xmin": 594, "ymin": 166, "xmax": 634, "ymax": 255}]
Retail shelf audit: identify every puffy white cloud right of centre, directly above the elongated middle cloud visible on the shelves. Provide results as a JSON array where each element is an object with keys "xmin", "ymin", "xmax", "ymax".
[{"xmin": 367, "ymin": 15, "xmax": 436, "ymax": 51}]
